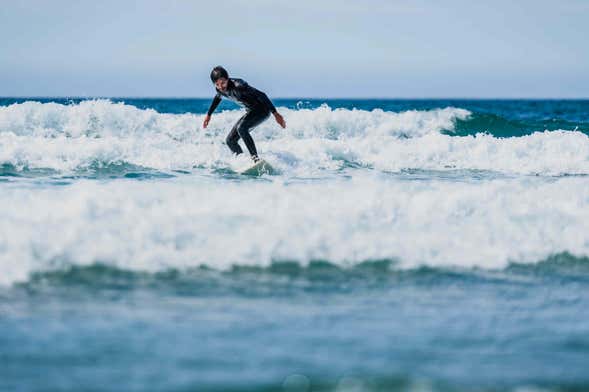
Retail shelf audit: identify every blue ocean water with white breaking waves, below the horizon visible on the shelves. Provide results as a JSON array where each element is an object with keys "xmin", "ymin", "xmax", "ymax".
[{"xmin": 0, "ymin": 97, "xmax": 589, "ymax": 392}]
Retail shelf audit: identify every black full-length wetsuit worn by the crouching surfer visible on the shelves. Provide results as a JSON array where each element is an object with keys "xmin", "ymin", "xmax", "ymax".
[{"xmin": 208, "ymin": 78, "xmax": 276, "ymax": 156}]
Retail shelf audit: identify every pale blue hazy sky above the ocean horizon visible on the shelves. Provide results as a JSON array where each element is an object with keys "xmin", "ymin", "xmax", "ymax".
[{"xmin": 0, "ymin": 0, "xmax": 589, "ymax": 98}]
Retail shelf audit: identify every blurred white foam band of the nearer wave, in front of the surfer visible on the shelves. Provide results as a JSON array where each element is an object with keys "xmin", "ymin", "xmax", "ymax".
[{"xmin": 0, "ymin": 174, "xmax": 589, "ymax": 284}]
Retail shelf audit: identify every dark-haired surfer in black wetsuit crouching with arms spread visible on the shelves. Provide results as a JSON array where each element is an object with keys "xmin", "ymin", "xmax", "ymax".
[{"xmin": 202, "ymin": 66, "xmax": 286, "ymax": 162}]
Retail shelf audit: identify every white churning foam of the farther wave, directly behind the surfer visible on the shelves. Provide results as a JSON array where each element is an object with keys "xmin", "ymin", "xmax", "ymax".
[{"xmin": 0, "ymin": 100, "xmax": 589, "ymax": 176}]
